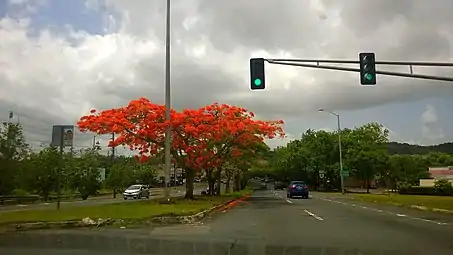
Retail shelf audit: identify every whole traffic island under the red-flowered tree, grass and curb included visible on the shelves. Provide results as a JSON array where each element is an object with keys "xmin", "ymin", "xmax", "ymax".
[{"xmin": 0, "ymin": 192, "xmax": 250, "ymax": 232}]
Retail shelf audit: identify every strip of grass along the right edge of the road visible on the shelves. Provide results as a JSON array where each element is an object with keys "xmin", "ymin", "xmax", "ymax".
[{"xmin": 348, "ymin": 194, "xmax": 453, "ymax": 210}]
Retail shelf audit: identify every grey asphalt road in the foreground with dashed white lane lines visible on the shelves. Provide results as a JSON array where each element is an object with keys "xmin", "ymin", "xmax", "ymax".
[{"xmin": 0, "ymin": 190, "xmax": 453, "ymax": 255}]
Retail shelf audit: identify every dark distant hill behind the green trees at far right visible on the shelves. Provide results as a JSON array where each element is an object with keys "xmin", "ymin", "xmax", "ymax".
[{"xmin": 387, "ymin": 142, "xmax": 453, "ymax": 154}]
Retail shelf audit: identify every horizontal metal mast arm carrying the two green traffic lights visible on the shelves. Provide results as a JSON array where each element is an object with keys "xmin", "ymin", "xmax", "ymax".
[{"xmin": 265, "ymin": 59, "xmax": 453, "ymax": 82}]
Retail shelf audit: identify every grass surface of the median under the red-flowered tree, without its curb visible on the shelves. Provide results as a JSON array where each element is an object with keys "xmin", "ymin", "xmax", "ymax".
[{"xmin": 0, "ymin": 191, "xmax": 251, "ymax": 225}]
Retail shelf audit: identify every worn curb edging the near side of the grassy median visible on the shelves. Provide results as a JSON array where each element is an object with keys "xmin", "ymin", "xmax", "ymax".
[{"xmin": 5, "ymin": 194, "xmax": 250, "ymax": 232}]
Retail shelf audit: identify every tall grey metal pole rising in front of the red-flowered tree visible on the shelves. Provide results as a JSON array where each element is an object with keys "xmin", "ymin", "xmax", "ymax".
[{"xmin": 164, "ymin": 0, "xmax": 171, "ymax": 200}]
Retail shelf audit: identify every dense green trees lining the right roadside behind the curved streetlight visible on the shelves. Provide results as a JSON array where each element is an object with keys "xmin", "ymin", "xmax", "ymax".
[{"xmin": 259, "ymin": 122, "xmax": 453, "ymax": 192}]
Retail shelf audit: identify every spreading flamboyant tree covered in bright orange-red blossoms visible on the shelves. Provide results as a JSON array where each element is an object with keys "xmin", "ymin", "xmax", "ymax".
[{"xmin": 78, "ymin": 98, "xmax": 284, "ymax": 198}]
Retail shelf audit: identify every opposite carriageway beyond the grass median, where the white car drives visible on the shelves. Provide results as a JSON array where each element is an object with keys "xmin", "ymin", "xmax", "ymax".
[{"xmin": 0, "ymin": 185, "xmax": 202, "ymax": 213}]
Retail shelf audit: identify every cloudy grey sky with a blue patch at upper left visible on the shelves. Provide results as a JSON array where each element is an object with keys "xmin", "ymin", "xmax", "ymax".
[{"xmin": 0, "ymin": 0, "xmax": 453, "ymax": 155}]
